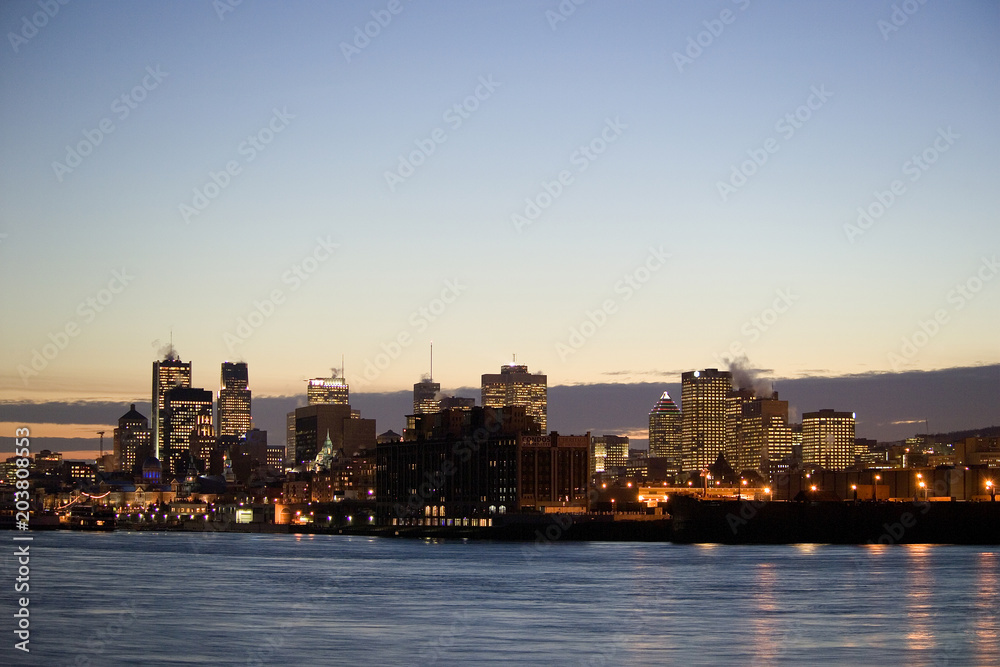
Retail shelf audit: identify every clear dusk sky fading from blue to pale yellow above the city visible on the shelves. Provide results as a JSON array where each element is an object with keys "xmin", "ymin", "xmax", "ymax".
[{"xmin": 0, "ymin": 0, "xmax": 1000, "ymax": 454}]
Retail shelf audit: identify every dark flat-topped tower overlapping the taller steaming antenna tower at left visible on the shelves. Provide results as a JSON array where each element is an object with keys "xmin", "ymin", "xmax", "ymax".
[{"xmin": 159, "ymin": 387, "xmax": 215, "ymax": 480}]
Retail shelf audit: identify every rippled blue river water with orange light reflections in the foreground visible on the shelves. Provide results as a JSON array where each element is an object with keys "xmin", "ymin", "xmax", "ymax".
[{"xmin": 7, "ymin": 532, "xmax": 1000, "ymax": 665}]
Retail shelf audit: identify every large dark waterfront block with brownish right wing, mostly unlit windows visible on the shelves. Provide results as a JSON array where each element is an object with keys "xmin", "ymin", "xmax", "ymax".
[{"xmin": 375, "ymin": 406, "xmax": 590, "ymax": 526}]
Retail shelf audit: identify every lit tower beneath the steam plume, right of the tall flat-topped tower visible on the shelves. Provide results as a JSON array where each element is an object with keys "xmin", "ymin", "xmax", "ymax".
[{"xmin": 732, "ymin": 392, "xmax": 792, "ymax": 480}]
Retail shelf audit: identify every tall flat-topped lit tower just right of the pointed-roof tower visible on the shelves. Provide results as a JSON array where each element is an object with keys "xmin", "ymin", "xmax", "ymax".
[{"xmin": 681, "ymin": 368, "xmax": 733, "ymax": 470}]
